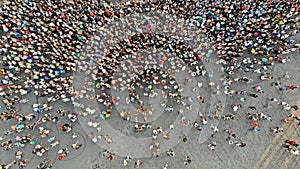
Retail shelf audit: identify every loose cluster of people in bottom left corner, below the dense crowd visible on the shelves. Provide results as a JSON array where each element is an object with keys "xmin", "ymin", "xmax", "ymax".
[{"xmin": 1, "ymin": 105, "xmax": 82, "ymax": 168}]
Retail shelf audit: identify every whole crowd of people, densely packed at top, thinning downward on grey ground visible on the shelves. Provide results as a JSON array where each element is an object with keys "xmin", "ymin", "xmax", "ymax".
[{"xmin": 0, "ymin": 0, "xmax": 300, "ymax": 168}]
